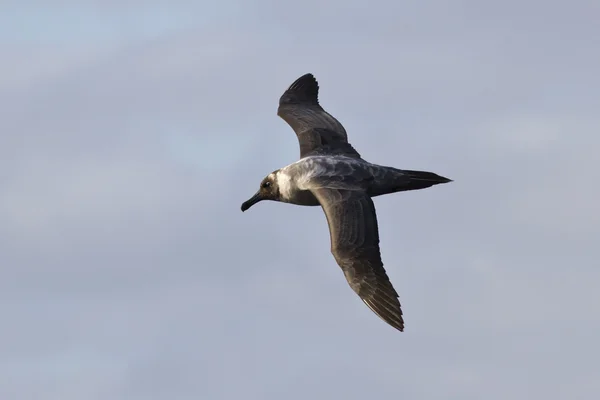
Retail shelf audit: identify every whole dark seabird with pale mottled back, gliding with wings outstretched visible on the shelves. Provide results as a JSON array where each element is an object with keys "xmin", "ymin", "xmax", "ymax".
[{"xmin": 241, "ymin": 73, "xmax": 452, "ymax": 332}]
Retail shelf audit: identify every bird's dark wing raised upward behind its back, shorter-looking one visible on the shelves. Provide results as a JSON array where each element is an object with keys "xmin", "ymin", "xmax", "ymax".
[{"xmin": 277, "ymin": 74, "xmax": 360, "ymax": 158}]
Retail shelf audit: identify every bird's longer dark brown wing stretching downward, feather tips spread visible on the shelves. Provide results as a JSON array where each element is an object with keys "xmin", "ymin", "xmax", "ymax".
[{"xmin": 311, "ymin": 188, "xmax": 404, "ymax": 331}]
